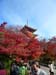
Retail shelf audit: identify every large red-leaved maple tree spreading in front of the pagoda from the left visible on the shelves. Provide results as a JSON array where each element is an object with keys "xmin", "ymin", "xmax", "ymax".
[{"xmin": 0, "ymin": 23, "xmax": 42, "ymax": 60}]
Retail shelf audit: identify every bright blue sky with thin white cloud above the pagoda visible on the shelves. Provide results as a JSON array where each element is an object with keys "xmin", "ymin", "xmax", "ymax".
[{"xmin": 0, "ymin": 0, "xmax": 56, "ymax": 39}]
